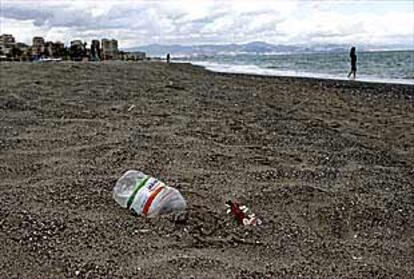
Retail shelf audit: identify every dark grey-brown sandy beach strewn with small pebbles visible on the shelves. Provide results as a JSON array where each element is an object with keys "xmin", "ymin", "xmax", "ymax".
[{"xmin": 0, "ymin": 62, "xmax": 414, "ymax": 279}]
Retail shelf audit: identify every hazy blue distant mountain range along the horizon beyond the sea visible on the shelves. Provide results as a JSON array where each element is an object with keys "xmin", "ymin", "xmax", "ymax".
[{"xmin": 123, "ymin": 41, "xmax": 410, "ymax": 56}]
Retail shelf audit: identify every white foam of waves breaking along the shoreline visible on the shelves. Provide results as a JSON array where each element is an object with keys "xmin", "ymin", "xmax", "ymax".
[{"xmin": 186, "ymin": 61, "xmax": 414, "ymax": 85}]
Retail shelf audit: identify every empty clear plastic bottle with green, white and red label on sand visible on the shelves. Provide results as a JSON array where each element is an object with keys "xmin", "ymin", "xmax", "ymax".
[{"xmin": 113, "ymin": 170, "xmax": 187, "ymax": 217}]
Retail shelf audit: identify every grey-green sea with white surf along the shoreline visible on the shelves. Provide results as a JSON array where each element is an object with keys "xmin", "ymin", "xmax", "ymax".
[{"xmin": 177, "ymin": 50, "xmax": 414, "ymax": 85}]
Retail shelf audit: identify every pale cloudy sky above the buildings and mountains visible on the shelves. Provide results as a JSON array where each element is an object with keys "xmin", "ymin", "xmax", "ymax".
[{"xmin": 0, "ymin": 0, "xmax": 414, "ymax": 48}]
